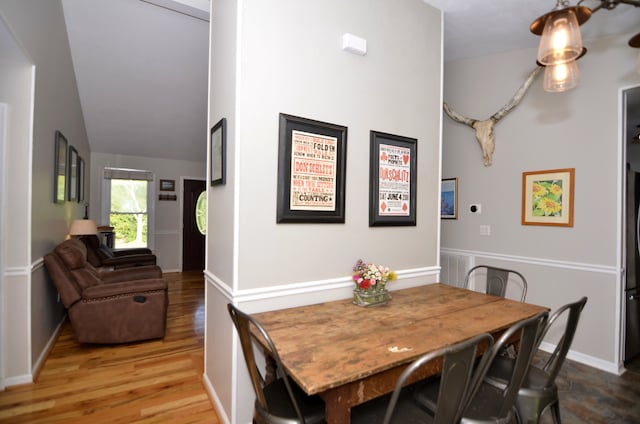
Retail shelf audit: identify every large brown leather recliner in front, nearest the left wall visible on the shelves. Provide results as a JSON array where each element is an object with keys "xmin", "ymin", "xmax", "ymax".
[{"xmin": 44, "ymin": 239, "xmax": 169, "ymax": 343}]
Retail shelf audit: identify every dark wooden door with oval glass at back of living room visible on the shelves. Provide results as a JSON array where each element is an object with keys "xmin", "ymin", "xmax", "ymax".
[{"xmin": 182, "ymin": 180, "xmax": 206, "ymax": 271}]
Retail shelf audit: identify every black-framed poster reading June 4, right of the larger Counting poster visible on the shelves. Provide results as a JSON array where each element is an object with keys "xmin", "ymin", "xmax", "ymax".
[{"xmin": 369, "ymin": 131, "xmax": 418, "ymax": 227}]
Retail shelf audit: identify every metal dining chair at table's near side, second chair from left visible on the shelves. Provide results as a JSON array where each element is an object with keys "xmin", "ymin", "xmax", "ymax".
[{"xmin": 351, "ymin": 333, "xmax": 493, "ymax": 424}]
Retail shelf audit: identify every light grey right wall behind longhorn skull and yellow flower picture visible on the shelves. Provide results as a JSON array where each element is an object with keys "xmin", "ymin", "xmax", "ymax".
[{"xmin": 442, "ymin": 34, "xmax": 640, "ymax": 371}]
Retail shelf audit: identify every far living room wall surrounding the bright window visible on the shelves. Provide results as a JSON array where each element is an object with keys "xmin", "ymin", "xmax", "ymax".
[{"xmin": 89, "ymin": 152, "xmax": 207, "ymax": 272}]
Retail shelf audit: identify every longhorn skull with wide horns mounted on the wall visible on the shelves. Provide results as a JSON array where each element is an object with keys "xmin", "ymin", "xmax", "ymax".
[{"xmin": 442, "ymin": 66, "xmax": 543, "ymax": 166}]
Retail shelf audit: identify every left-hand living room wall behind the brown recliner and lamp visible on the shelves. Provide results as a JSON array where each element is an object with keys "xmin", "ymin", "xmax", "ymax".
[{"xmin": 0, "ymin": 0, "xmax": 89, "ymax": 384}]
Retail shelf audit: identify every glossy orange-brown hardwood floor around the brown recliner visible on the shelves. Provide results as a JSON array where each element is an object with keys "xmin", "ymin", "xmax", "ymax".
[{"xmin": 0, "ymin": 271, "xmax": 220, "ymax": 424}]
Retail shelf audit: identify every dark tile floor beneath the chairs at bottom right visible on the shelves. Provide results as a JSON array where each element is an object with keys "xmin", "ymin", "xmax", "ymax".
[{"xmin": 535, "ymin": 353, "xmax": 640, "ymax": 424}]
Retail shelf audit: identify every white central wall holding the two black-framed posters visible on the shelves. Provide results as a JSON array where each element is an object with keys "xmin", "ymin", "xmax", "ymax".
[{"xmin": 205, "ymin": 0, "xmax": 441, "ymax": 422}]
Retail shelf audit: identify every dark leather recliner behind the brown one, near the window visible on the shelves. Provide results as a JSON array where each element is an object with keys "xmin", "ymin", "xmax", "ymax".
[{"xmin": 79, "ymin": 235, "xmax": 156, "ymax": 269}]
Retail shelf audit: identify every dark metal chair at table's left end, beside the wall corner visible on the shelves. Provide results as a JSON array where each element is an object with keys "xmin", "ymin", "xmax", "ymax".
[{"xmin": 227, "ymin": 303, "xmax": 325, "ymax": 424}]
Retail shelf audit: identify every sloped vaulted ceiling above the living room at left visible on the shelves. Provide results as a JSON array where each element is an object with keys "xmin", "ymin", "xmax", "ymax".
[{"xmin": 62, "ymin": 0, "xmax": 209, "ymax": 161}]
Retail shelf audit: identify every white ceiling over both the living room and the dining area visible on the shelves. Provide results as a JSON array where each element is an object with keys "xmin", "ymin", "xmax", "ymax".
[{"xmin": 62, "ymin": 0, "xmax": 640, "ymax": 161}]
